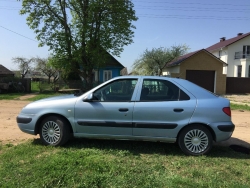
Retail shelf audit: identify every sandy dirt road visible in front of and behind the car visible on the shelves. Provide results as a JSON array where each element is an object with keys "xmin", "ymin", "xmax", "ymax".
[{"xmin": 0, "ymin": 95, "xmax": 250, "ymax": 148}]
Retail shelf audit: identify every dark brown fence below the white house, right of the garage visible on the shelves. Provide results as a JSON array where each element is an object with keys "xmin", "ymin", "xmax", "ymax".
[{"xmin": 226, "ymin": 77, "xmax": 250, "ymax": 94}]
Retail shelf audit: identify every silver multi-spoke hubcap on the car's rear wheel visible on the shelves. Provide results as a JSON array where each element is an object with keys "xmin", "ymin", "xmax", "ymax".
[{"xmin": 184, "ymin": 129, "xmax": 208, "ymax": 153}]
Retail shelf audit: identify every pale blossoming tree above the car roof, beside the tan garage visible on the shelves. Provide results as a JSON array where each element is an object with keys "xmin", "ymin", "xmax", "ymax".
[{"xmin": 132, "ymin": 45, "xmax": 189, "ymax": 76}]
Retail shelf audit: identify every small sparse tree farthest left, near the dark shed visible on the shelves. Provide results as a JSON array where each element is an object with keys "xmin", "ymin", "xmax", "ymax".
[{"xmin": 12, "ymin": 57, "xmax": 33, "ymax": 78}]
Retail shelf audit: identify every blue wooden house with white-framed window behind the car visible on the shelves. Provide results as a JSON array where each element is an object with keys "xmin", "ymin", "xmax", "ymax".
[{"xmin": 93, "ymin": 52, "xmax": 125, "ymax": 82}]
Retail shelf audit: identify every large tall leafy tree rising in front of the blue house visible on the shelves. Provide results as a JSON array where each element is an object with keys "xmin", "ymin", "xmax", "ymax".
[{"xmin": 20, "ymin": 0, "xmax": 137, "ymax": 89}]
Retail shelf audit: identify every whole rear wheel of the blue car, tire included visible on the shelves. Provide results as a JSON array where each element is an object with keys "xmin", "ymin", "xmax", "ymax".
[{"xmin": 178, "ymin": 125, "xmax": 213, "ymax": 156}]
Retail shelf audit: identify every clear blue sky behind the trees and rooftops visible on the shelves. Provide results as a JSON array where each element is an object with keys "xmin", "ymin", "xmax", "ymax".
[{"xmin": 0, "ymin": 0, "xmax": 250, "ymax": 72}]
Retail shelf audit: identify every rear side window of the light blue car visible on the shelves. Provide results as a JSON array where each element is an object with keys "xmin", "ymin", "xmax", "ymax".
[{"xmin": 140, "ymin": 79, "xmax": 190, "ymax": 101}]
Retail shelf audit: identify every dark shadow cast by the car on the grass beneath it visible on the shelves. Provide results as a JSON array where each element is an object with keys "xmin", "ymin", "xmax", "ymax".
[{"xmin": 32, "ymin": 138, "xmax": 250, "ymax": 159}]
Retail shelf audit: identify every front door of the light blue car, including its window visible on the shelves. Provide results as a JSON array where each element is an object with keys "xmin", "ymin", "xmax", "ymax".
[{"xmin": 75, "ymin": 79, "xmax": 137, "ymax": 136}]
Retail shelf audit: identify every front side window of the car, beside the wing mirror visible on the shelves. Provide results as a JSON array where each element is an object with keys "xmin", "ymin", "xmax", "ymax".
[{"xmin": 93, "ymin": 79, "xmax": 137, "ymax": 102}]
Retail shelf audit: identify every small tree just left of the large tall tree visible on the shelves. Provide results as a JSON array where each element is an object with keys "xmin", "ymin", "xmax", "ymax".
[{"xmin": 34, "ymin": 57, "xmax": 59, "ymax": 84}]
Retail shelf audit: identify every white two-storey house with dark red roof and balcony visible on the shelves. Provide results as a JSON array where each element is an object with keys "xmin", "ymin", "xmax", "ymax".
[{"xmin": 206, "ymin": 32, "xmax": 250, "ymax": 77}]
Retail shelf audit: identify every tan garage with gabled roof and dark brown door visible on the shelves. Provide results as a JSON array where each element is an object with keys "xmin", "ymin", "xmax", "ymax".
[{"xmin": 163, "ymin": 49, "xmax": 227, "ymax": 94}]
